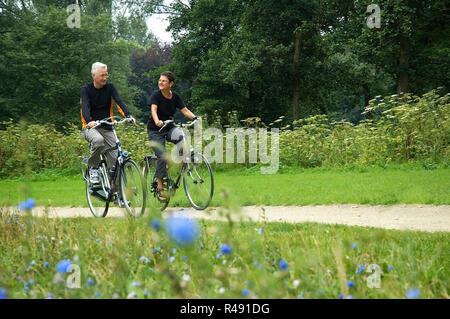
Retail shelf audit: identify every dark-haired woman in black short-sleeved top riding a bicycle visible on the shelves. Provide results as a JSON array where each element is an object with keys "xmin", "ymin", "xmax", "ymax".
[{"xmin": 147, "ymin": 71, "xmax": 200, "ymax": 201}]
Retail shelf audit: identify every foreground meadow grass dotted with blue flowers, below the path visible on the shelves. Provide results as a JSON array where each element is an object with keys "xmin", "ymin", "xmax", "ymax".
[{"xmin": 0, "ymin": 209, "xmax": 450, "ymax": 299}]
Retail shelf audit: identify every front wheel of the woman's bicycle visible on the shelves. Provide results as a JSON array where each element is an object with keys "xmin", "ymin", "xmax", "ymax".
[{"xmin": 183, "ymin": 153, "xmax": 214, "ymax": 210}]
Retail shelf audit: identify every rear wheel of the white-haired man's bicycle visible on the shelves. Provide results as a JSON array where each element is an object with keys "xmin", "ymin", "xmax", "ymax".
[{"xmin": 85, "ymin": 168, "xmax": 109, "ymax": 218}]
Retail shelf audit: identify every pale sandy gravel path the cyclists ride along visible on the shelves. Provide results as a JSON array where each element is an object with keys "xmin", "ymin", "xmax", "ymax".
[{"xmin": 7, "ymin": 204, "xmax": 450, "ymax": 232}]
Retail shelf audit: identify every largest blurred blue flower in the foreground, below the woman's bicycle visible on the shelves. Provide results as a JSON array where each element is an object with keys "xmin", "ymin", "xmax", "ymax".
[{"xmin": 166, "ymin": 217, "xmax": 199, "ymax": 246}]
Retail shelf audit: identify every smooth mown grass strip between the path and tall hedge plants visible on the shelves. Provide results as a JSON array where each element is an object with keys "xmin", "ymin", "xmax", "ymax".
[{"xmin": 0, "ymin": 167, "xmax": 450, "ymax": 207}]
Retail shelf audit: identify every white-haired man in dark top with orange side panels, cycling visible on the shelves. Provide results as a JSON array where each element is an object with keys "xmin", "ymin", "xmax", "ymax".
[{"xmin": 81, "ymin": 62, "xmax": 136, "ymax": 205}]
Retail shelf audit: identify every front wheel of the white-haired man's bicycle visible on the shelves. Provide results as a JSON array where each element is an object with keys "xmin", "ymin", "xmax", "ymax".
[{"xmin": 120, "ymin": 160, "xmax": 147, "ymax": 217}]
